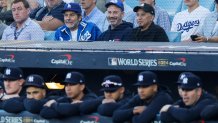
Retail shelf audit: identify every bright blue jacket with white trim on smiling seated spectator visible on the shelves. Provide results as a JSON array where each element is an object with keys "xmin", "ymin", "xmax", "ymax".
[{"xmin": 55, "ymin": 21, "xmax": 101, "ymax": 41}]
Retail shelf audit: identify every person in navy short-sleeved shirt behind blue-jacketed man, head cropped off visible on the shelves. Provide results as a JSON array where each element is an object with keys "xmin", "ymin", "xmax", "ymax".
[{"xmin": 35, "ymin": 0, "xmax": 65, "ymax": 31}]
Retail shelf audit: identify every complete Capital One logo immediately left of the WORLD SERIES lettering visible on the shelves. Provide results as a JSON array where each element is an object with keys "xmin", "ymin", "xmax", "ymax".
[{"xmin": 51, "ymin": 54, "xmax": 73, "ymax": 65}]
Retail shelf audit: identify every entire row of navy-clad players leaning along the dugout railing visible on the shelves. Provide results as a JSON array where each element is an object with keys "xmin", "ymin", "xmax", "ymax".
[{"xmin": 0, "ymin": 68, "xmax": 218, "ymax": 123}]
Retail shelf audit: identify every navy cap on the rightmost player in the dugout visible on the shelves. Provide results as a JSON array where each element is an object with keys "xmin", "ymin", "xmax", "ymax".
[{"xmin": 178, "ymin": 72, "xmax": 202, "ymax": 90}]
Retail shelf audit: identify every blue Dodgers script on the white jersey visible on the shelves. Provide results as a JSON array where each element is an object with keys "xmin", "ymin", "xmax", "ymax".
[{"xmin": 177, "ymin": 20, "xmax": 200, "ymax": 33}]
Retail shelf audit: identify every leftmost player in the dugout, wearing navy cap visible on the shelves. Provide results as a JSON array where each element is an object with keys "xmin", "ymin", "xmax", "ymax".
[{"xmin": 0, "ymin": 68, "xmax": 25, "ymax": 113}]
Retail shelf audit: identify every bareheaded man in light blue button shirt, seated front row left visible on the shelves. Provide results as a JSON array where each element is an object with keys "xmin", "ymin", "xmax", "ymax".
[{"xmin": 2, "ymin": 0, "xmax": 44, "ymax": 41}]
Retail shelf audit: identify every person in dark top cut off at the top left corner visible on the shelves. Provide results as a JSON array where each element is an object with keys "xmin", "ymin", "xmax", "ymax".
[{"xmin": 0, "ymin": 0, "xmax": 14, "ymax": 25}]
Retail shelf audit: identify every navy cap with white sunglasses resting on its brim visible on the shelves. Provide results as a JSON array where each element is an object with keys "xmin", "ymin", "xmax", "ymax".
[{"xmin": 101, "ymin": 75, "xmax": 123, "ymax": 92}]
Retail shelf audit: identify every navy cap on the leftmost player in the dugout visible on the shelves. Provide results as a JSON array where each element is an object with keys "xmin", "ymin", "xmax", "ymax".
[{"xmin": 2, "ymin": 68, "xmax": 23, "ymax": 80}]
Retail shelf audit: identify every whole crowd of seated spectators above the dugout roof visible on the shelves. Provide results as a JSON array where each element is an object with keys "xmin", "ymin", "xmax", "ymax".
[{"xmin": 0, "ymin": 0, "xmax": 218, "ymax": 42}]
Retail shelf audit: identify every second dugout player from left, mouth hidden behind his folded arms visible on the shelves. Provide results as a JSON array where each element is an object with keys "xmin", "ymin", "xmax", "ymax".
[{"xmin": 3, "ymin": 74, "xmax": 46, "ymax": 113}]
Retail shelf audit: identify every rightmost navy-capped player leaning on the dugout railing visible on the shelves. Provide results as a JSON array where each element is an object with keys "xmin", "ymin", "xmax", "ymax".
[{"xmin": 160, "ymin": 72, "xmax": 215, "ymax": 123}]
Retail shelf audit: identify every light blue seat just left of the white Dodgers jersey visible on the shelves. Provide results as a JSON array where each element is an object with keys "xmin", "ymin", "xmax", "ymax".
[{"xmin": 156, "ymin": 0, "xmax": 183, "ymax": 22}]
